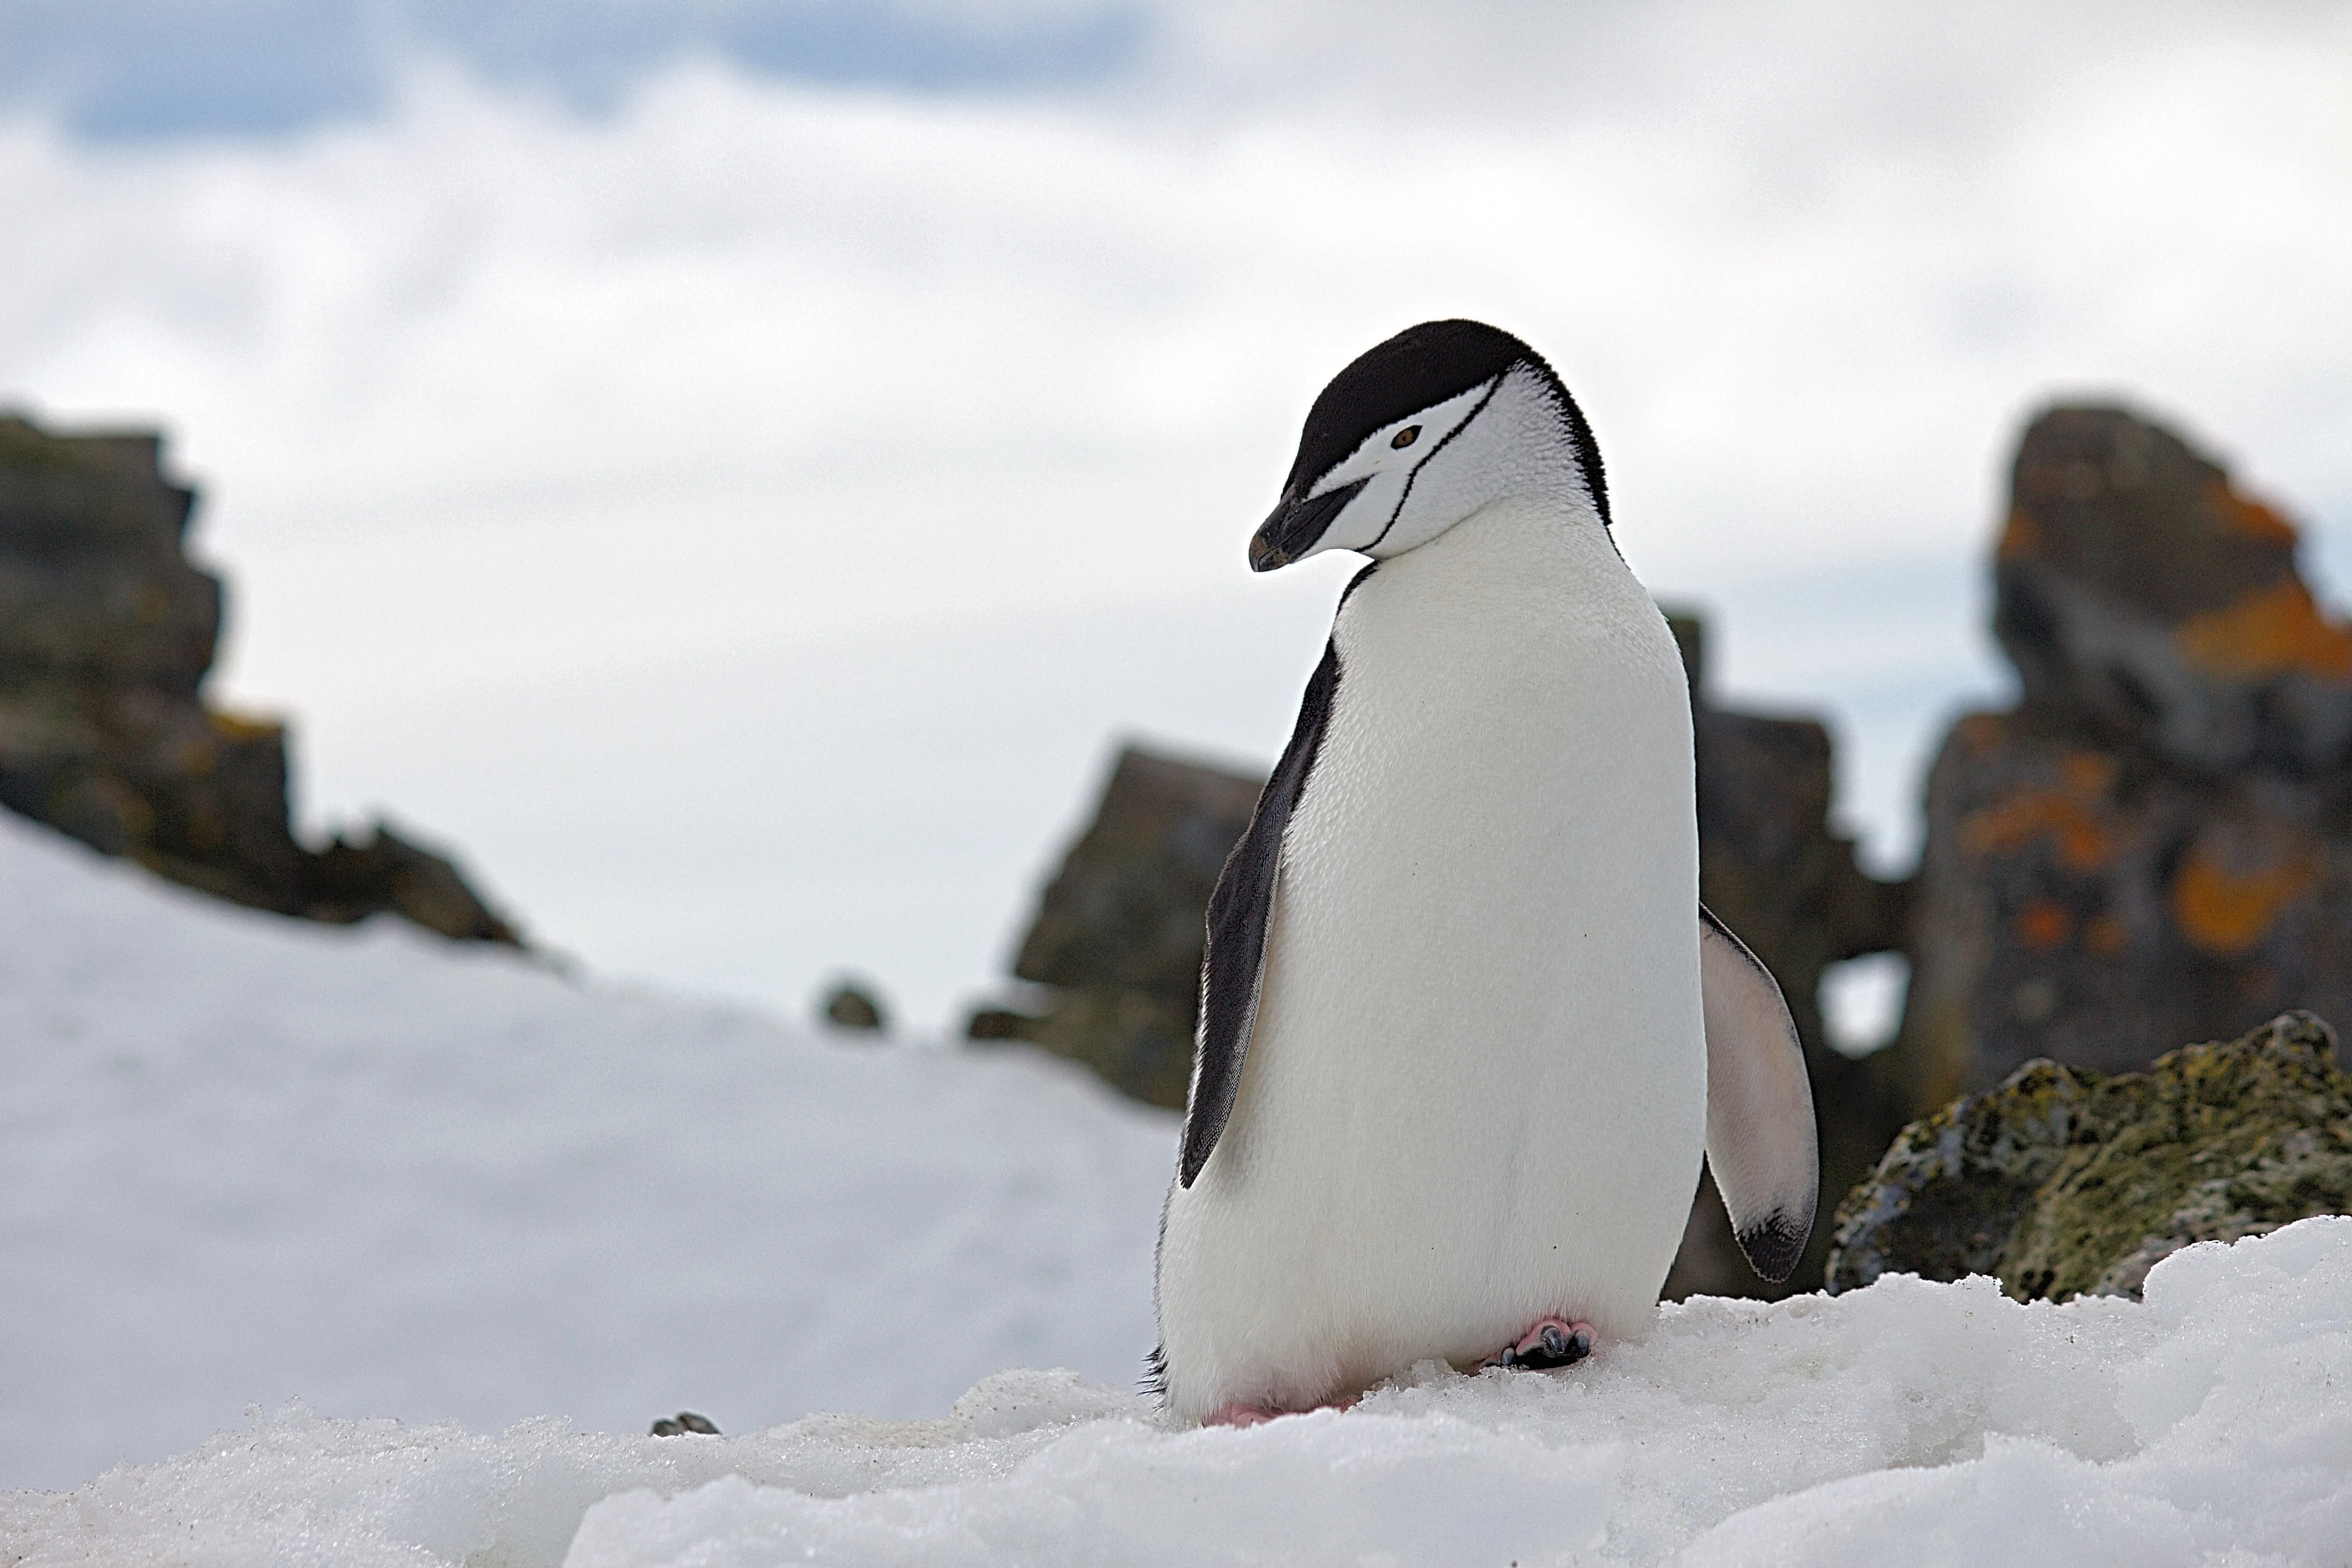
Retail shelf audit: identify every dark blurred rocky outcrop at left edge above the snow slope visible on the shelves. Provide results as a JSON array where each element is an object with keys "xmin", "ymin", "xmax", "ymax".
[{"xmin": 0, "ymin": 416, "xmax": 517, "ymax": 943}]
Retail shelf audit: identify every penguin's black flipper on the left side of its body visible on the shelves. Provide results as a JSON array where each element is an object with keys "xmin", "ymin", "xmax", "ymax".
[{"xmin": 1178, "ymin": 644, "xmax": 1338, "ymax": 1187}]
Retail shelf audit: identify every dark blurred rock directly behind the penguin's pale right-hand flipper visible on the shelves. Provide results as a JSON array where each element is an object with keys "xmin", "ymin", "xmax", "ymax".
[{"xmin": 1665, "ymin": 613, "xmax": 1910, "ymax": 1300}]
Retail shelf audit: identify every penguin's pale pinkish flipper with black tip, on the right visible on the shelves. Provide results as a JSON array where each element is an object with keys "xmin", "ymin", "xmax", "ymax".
[{"xmin": 1698, "ymin": 905, "xmax": 1820, "ymax": 1284}]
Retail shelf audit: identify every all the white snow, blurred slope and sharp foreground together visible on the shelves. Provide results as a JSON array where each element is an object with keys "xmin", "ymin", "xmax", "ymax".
[{"xmin": 0, "ymin": 818, "xmax": 2352, "ymax": 1568}]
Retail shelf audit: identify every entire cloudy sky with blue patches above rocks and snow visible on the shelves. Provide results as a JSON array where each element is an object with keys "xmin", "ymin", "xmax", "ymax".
[{"xmin": 0, "ymin": 0, "xmax": 2352, "ymax": 1044}]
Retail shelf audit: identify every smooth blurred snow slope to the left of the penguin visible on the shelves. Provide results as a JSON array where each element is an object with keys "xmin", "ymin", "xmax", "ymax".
[{"xmin": 0, "ymin": 813, "xmax": 1176, "ymax": 1495}]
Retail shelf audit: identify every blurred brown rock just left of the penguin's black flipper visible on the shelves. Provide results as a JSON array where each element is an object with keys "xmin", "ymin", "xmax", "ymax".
[{"xmin": 967, "ymin": 748, "xmax": 1265, "ymax": 1107}]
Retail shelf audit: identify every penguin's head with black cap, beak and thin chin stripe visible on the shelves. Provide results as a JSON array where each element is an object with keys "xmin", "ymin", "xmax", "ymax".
[{"xmin": 1249, "ymin": 322, "xmax": 1609, "ymax": 571}]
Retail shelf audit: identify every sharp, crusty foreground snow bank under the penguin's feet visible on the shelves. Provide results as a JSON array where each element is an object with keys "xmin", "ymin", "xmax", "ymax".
[{"xmin": 0, "ymin": 1218, "xmax": 2352, "ymax": 1568}]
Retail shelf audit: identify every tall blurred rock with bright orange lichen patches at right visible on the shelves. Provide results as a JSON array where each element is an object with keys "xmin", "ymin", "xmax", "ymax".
[{"xmin": 1886, "ymin": 407, "xmax": 2352, "ymax": 1112}]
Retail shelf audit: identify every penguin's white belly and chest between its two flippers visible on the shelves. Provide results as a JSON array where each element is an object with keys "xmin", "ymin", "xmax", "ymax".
[{"xmin": 1160, "ymin": 501, "xmax": 1708, "ymax": 1417}]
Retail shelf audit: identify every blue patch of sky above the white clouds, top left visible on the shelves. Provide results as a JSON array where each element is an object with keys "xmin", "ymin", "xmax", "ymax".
[{"xmin": 0, "ymin": 0, "xmax": 1141, "ymax": 141}]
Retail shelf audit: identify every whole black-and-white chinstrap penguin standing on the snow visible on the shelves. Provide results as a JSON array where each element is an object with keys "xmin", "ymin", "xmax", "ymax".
[{"xmin": 1152, "ymin": 320, "xmax": 1818, "ymax": 1425}]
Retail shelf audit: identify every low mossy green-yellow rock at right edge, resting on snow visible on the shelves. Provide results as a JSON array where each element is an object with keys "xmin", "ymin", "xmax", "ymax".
[{"xmin": 1828, "ymin": 1013, "xmax": 2352, "ymax": 1300}]
